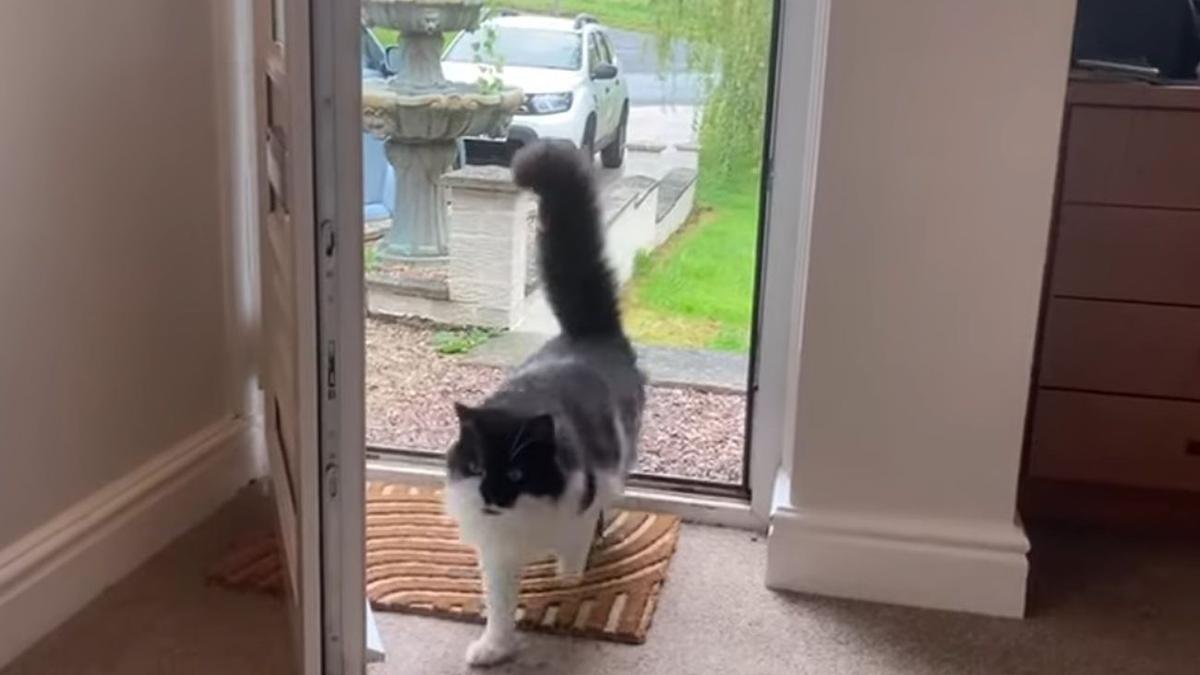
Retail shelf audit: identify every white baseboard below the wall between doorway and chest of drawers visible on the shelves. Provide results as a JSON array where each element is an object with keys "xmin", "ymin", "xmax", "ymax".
[{"xmin": 767, "ymin": 506, "xmax": 1030, "ymax": 617}]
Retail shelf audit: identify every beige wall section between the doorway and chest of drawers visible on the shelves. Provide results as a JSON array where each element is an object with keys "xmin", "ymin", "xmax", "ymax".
[{"xmin": 791, "ymin": 0, "xmax": 1074, "ymax": 522}]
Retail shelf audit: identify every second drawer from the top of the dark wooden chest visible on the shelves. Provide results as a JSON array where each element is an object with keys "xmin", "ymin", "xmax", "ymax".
[{"xmin": 1050, "ymin": 200, "xmax": 1200, "ymax": 306}]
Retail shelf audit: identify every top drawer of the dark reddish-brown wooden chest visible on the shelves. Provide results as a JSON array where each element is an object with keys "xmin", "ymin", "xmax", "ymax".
[{"xmin": 1062, "ymin": 106, "xmax": 1200, "ymax": 209}]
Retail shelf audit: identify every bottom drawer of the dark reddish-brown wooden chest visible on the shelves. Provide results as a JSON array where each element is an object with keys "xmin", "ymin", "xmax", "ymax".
[{"xmin": 1028, "ymin": 390, "xmax": 1200, "ymax": 490}]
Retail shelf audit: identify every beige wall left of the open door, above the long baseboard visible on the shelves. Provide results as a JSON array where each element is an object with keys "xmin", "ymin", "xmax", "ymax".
[{"xmin": 0, "ymin": 0, "xmax": 230, "ymax": 548}]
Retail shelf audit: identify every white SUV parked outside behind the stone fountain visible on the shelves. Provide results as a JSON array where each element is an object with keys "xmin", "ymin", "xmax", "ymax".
[{"xmin": 442, "ymin": 16, "xmax": 629, "ymax": 168}]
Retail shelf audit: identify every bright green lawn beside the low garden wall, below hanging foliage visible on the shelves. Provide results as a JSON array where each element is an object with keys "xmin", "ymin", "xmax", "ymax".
[{"xmin": 622, "ymin": 177, "xmax": 758, "ymax": 352}]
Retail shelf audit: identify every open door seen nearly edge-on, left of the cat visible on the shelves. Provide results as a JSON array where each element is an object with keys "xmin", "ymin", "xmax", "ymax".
[{"xmin": 254, "ymin": 0, "xmax": 368, "ymax": 675}]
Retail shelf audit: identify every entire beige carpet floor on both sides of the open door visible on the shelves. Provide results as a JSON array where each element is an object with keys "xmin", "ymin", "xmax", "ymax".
[{"xmin": 9, "ymin": 485, "xmax": 1200, "ymax": 675}]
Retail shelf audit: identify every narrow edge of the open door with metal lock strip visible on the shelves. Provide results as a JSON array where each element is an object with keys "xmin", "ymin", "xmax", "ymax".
[{"xmin": 308, "ymin": 0, "xmax": 370, "ymax": 675}]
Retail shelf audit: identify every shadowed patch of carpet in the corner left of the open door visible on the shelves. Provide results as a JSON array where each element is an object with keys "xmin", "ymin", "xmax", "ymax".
[{"xmin": 0, "ymin": 489, "xmax": 293, "ymax": 675}]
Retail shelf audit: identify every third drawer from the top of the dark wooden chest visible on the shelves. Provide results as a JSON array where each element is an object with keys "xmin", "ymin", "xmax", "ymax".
[{"xmin": 1038, "ymin": 298, "xmax": 1200, "ymax": 400}]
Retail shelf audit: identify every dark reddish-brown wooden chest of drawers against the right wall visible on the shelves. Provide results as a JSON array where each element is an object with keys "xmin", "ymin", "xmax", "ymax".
[{"xmin": 1021, "ymin": 82, "xmax": 1200, "ymax": 527}]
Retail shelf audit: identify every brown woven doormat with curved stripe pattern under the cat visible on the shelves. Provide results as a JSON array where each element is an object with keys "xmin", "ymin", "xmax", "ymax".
[{"xmin": 209, "ymin": 483, "xmax": 679, "ymax": 644}]
